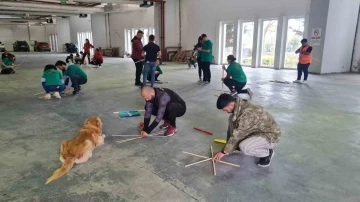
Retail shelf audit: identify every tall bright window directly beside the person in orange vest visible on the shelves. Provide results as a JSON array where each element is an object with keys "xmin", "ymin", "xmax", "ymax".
[{"xmin": 284, "ymin": 18, "xmax": 305, "ymax": 68}]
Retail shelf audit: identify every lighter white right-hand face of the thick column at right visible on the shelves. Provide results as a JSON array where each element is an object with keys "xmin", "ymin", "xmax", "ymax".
[{"xmin": 321, "ymin": 0, "xmax": 359, "ymax": 74}]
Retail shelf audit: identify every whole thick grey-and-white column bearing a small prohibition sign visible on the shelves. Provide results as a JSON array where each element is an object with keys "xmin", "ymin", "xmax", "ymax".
[{"xmin": 308, "ymin": 0, "xmax": 360, "ymax": 74}]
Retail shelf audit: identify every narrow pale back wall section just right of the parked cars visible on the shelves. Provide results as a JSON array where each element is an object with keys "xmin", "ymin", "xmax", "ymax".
[{"xmin": 56, "ymin": 17, "xmax": 71, "ymax": 52}]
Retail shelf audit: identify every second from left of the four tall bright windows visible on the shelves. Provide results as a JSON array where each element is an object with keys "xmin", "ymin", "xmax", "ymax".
[{"xmin": 241, "ymin": 22, "xmax": 254, "ymax": 65}]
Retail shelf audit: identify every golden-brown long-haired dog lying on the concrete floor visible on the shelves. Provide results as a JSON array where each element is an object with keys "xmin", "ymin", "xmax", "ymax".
[{"xmin": 46, "ymin": 116, "xmax": 105, "ymax": 184}]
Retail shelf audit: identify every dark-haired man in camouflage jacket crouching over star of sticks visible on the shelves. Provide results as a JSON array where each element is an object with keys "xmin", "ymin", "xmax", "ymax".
[{"xmin": 214, "ymin": 94, "xmax": 281, "ymax": 167}]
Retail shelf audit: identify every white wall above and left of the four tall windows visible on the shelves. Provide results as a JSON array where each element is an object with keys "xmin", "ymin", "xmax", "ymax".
[{"xmin": 179, "ymin": 0, "xmax": 310, "ymax": 63}]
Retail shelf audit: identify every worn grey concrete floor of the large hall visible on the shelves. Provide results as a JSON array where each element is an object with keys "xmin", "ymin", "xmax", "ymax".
[{"xmin": 0, "ymin": 53, "xmax": 360, "ymax": 202}]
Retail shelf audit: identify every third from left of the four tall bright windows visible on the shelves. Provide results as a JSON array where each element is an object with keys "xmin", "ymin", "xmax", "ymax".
[{"xmin": 261, "ymin": 20, "xmax": 278, "ymax": 67}]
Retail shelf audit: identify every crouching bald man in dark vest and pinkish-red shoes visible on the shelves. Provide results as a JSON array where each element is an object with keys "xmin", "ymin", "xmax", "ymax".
[{"xmin": 140, "ymin": 86, "xmax": 186, "ymax": 137}]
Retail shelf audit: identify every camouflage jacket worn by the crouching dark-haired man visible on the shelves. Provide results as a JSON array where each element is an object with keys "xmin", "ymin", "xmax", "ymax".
[{"xmin": 223, "ymin": 99, "xmax": 281, "ymax": 153}]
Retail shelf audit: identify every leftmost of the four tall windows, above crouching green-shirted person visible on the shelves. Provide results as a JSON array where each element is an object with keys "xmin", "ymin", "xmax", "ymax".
[{"xmin": 222, "ymin": 22, "xmax": 235, "ymax": 63}]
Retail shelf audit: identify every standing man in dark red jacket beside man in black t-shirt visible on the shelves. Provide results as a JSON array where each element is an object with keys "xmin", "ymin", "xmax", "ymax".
[{"xmin": 131, "ymin": 30, "xmax": 144, "ymax": 86}]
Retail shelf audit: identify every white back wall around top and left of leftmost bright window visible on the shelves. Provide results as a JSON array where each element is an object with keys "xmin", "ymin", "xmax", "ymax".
[{"xmin": 69, "ymin": 15, "xmax": 92, "ymax": 44}]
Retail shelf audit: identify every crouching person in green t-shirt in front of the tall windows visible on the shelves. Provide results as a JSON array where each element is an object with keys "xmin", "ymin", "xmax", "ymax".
[{"xmin": 221, "ymin": 55, "xmax": 253, "ymax": 99}]
